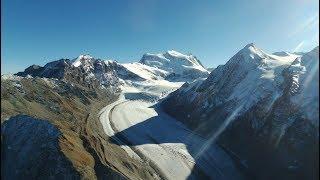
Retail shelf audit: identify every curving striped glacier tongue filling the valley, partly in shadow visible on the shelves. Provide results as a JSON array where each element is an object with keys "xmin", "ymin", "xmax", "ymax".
[{"xmin": 100, "ymin": 88, "xmax": 242, "ymax": 179}]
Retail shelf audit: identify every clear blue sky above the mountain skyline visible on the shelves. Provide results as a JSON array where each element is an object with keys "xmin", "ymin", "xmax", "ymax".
[{"xmin": 1, "ymin": 0, "xmax": 319, "ymax": 74}]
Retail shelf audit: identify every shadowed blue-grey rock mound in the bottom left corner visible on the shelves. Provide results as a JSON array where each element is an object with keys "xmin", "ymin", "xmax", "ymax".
[{"xmin": 1, "ymin": 115, "xmax": 80, "ymax": 179}]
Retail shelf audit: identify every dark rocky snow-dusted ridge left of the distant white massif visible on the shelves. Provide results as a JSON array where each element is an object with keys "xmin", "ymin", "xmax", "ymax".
[{"xmin": 16, "ymin": 56, "xmax": 119, "ymax": 88}]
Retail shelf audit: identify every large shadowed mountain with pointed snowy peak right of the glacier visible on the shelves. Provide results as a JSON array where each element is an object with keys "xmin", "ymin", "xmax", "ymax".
[{"xmin": 163, "ymin": 44, "xmax": 319, "ymax": 179}]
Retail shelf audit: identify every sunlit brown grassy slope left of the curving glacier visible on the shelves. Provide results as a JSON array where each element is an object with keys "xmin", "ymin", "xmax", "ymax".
[{"xmin": 1, "ymin": 78, "xmax": 159, "ymax": 179}]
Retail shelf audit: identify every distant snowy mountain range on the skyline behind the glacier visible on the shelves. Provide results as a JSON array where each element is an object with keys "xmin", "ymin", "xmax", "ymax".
[{"xmin": 16, "ymin": 50, "xmax": 209, "ymax": 86}]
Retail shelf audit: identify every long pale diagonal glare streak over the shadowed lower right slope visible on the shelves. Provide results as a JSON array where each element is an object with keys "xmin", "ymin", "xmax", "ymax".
[{"xmin": 195, "ymin": 105, "xmax": 243, "ymax": 159}]
